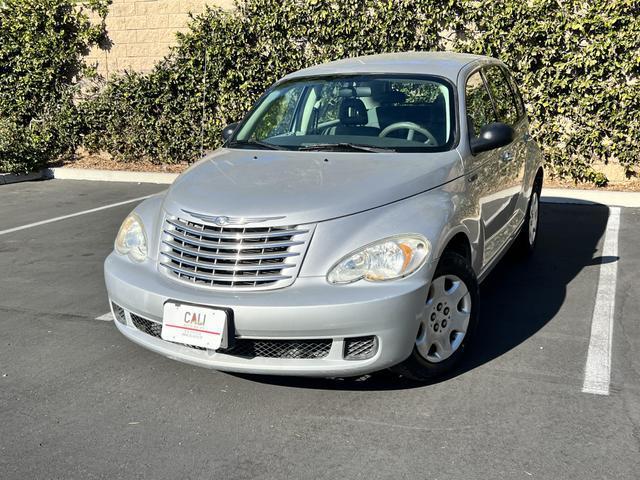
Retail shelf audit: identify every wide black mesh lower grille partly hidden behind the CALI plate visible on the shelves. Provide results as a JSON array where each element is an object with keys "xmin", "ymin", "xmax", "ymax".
[{"xmin": 129, "ymin": 313, "xmax": 332, "ymax": 359}]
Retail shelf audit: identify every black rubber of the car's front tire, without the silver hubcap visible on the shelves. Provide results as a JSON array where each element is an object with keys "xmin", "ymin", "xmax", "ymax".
[{"xmin": 391, "ymin": 252, "xmax": 480, "ymax": 382}]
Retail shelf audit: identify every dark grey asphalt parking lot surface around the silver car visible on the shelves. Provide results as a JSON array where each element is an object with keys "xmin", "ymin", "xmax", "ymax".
[{"xmin": 0, "ymin": 180, "xmax": 640, "ymax": 480}]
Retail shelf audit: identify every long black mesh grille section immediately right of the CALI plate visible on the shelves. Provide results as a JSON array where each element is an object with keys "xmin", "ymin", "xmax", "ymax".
[{"xmin": 223, "ymin": 339, "xmax": 331, "ymax": 359}]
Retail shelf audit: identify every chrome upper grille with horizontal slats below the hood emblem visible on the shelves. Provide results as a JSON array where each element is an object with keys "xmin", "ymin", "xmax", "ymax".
[{"xmin": 160, "ymin": 216, "xmax": 313, "ymax": 289}]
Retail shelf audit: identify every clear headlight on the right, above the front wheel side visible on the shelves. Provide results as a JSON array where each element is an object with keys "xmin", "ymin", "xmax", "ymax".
[{"xmin": 327, "ymin": 234, "xmax": 431, "ymax": 283}]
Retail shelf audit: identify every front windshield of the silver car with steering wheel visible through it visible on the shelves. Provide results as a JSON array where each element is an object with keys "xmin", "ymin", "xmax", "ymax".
[{"xmin": 227, "ymin": 75, "xmax": 454, "ymax": 152}]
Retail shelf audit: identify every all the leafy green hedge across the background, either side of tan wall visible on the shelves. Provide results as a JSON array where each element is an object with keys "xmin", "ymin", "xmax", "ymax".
[{"xmin": 5, "ymin": 0, "xmax": 640, "ymax": 180}]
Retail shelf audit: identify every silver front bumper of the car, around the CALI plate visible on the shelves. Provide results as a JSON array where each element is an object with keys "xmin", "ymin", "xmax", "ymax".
[{"xmin": 105, "ymin": 253, "xmax": 431, "ymax": 377}]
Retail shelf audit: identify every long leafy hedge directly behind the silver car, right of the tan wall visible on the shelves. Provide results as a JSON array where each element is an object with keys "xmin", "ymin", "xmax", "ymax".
[{"xmin": 85, "ymin": 0, "xmax": 640, "ymax": 183}]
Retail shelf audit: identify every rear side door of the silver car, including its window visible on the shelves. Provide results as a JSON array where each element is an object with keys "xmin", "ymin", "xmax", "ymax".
[{"xmin": 483, "ymin": 65, "xmax": 527, "ymax": 231}]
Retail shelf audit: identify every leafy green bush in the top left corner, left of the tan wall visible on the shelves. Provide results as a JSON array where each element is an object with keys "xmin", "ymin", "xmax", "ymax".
[{"xmin": 0, "ymin": 0, "xmax": 110, "ymax": 172}]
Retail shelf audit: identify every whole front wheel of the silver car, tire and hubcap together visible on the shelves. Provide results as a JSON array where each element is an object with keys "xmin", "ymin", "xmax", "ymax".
[{"xmin": 391, "ymin": 252, "xmax": 480, "ymax": 382}]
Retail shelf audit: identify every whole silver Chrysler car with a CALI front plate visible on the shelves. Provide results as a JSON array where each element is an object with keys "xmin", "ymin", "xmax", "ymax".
[{"xmin": 105, "ymin": 53, "xmax": 543, "ymax": 380}]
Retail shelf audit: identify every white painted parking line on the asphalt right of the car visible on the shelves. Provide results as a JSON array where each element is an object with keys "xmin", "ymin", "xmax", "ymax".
[{"xmin": 582, "ymin": 207, "xmax": 620, "ymax": 395}]
